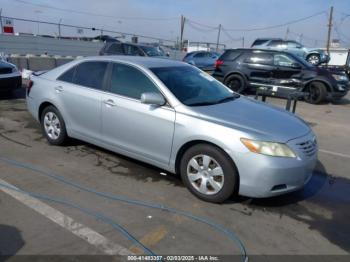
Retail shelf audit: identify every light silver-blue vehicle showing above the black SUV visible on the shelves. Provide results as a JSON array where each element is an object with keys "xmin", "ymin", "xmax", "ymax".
[{"xmin": 251, "ymin": 38, "xmax": 330, "ymax": 65}]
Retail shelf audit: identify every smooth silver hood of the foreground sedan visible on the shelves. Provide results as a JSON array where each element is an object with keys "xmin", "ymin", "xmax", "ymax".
[{"xmin": 187, "ymin": 96, "xmax": 310, "ymax": 142}]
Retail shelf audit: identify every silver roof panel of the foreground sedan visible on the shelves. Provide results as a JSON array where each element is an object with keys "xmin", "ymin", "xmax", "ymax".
[{"xmin": 80, "ymin": 55, "xmax": 188, "ymax": 68}]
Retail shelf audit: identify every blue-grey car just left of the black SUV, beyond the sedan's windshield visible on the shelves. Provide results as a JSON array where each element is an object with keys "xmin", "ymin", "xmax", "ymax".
[{"xmin": 183, "ymin": 51, "xmax": 220, "ymax": 71}]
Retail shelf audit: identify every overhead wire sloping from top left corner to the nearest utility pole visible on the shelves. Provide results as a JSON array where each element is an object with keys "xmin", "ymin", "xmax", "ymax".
[{"xmin": 13, "ymin": 0, "xmax": 179, "ymax": 21}]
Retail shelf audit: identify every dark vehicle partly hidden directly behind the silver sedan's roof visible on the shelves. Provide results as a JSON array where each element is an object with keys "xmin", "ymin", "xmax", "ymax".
[{"xmin": 99, "ymin": 42, "xmax": 167, "ymax": 57}]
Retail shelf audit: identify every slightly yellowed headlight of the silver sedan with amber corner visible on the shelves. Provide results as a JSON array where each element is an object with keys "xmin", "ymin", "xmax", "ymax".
[{"xmin": 241, "ymin": 138, "xmax": 297, "ymax": 157}]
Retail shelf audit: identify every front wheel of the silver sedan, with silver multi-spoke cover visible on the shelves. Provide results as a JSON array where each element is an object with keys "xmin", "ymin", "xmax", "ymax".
[{"xmin": 180, "ymin": 144, "xmax": 238, "ymax": 203}]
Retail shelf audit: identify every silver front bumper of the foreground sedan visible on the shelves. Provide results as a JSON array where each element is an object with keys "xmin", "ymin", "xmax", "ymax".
[{"xmin": 236, "ymin": 132, "xmax": 318, "ymax": 198}]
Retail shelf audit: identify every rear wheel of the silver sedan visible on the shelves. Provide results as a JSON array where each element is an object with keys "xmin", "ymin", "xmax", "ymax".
[{"xmin": 40, "ymin": 106, "xmax": 68, "ymax": 145}]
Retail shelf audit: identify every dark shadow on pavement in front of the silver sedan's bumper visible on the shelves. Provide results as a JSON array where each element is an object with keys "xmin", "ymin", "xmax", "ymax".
[{"xmin": 231, "ymin": 162, "xmax": 350, "ymax": 252}]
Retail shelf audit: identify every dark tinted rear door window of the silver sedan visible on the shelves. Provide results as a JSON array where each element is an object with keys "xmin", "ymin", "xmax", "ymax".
[{"xmin": 73, "ymin": 61, "xmax": 108, "ymax": 90}]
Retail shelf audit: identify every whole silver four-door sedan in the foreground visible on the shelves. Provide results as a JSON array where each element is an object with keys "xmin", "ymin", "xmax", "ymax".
[{"xmin": 26, "ymin": 56, "xmax": 318, "ymax": 202}]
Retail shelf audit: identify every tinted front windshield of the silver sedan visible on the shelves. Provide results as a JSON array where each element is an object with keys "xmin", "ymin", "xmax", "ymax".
[{"xmin": 151, "ymin": 66, "xmax": 239, "ymax": 106}]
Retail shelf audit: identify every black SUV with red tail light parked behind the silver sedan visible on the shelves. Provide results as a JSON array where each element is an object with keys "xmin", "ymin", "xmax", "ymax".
[{"xmin": 213, "ymin": 49, "xmax": 350, "ymax": 104}]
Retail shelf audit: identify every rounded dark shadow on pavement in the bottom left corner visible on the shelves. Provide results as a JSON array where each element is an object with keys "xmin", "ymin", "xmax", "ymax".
[{"xmin": 0, "ymin": 224, "xmax": 25, "ymax": 261}]
